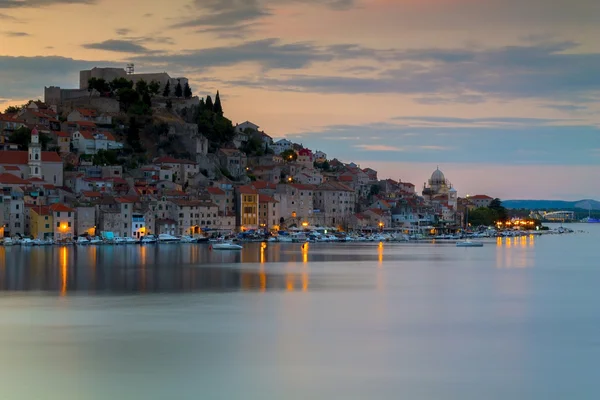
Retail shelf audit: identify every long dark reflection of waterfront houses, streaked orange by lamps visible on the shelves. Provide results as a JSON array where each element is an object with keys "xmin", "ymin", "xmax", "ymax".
[{"xmin": 0, "ymin": 243, "xmax": 394, "ymax": 296}]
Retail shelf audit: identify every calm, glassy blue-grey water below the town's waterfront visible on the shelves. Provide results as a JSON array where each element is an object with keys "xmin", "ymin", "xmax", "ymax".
[{"xmin": 0, "ymin": 224, "xmax": 600, "ymax": 400}]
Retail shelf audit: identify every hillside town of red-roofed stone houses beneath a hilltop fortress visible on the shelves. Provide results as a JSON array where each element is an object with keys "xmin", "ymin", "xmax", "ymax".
[{"xmin": 0, "ymin": 65, "xmax": 493, "ymax": 241}]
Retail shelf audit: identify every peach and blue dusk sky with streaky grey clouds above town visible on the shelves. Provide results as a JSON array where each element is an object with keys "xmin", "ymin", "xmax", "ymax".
[{"xmin": 0, "ymin": 0, "xmax": 600, "ymax": 200}]
